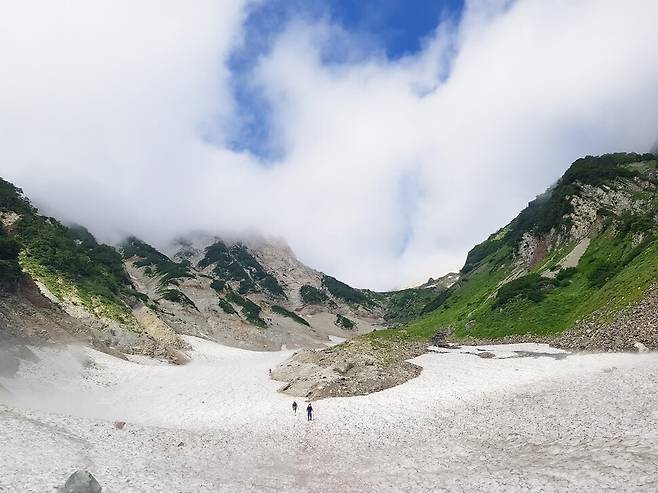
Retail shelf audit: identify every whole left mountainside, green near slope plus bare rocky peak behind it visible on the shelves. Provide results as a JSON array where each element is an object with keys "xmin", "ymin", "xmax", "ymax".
[{"xmin": 0, "ymin": 176, "xmax": 394, "ymax": 354}]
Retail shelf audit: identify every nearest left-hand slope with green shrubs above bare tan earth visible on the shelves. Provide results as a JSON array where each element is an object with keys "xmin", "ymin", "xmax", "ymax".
[{"xmin": 0, "ymin": 179, "xmax": 185, "ymax": 362}]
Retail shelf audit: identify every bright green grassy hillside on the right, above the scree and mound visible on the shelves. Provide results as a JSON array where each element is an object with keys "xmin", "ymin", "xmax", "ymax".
[{"xmin": 369, "ymin": 154, "xmax": 658, "ymax": 340}]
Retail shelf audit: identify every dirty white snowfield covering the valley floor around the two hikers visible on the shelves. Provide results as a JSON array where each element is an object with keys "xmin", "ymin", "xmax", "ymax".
[{"xmin": 0, "ymin": 337, "xmax": 658, "ymax": 492}]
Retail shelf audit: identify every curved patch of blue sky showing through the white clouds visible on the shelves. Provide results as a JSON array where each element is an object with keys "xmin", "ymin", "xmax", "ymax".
[{"xmin": 229, "ymin": 0, "xmax": 464, "ymax": 159}]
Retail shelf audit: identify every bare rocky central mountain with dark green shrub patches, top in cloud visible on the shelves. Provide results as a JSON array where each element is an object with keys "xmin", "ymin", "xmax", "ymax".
[{"xmin": 123, "ymin": 234, "xmax": 383, "ymax": 350}]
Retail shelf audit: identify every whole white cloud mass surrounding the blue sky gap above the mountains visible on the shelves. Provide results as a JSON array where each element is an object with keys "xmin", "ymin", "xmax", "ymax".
[{"xmin": 0, "ymin": 0, "xmax": 658, "ymax": 288}]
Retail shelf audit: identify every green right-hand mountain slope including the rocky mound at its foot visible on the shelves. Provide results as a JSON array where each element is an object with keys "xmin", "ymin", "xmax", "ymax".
[{"xmin": 274, "ymin": 154, "xmax": 658, "ymax": 398}]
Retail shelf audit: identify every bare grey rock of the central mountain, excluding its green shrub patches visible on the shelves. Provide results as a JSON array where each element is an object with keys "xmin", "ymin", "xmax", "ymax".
[{"xmin": 124, "ymin": 233, "xmax": 384, "ymax": 351}]
